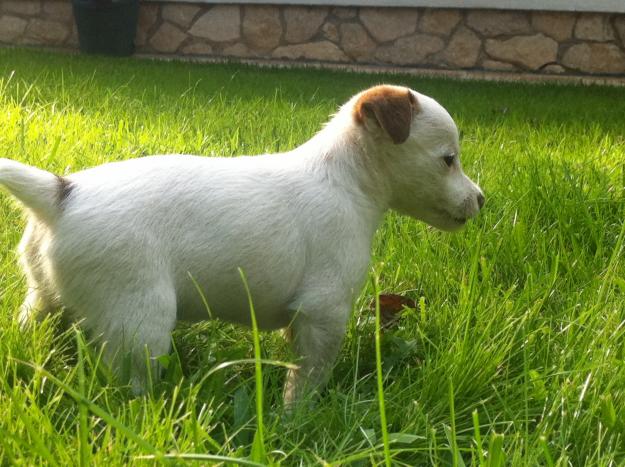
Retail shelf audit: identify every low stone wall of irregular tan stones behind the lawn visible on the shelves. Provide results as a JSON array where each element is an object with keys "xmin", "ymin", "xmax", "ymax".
[{"xmin": 0, "ymin": 0, "xmax": 625, "ymax": 75}]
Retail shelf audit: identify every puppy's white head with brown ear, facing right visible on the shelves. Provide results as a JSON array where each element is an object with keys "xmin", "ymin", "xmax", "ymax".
[{"xmin": 352, "ymin": 85, "xmax": 484, "ymax": 230}]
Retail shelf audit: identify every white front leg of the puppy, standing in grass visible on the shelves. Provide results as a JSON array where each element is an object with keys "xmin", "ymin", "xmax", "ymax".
[{"xmin": 284, "ymin": 308, "xmax": 349, "ymax": 407}]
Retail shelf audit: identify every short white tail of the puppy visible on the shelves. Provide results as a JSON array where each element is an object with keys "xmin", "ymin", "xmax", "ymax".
[{"xmin": 0, "ymin": 158, "xmax": 68, "ymax": 223}]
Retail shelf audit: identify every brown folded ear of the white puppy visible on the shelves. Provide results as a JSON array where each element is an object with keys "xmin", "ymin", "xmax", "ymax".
[{"xmin": 354, "ymin": 85, "xmax": 419, "ymax": 144}]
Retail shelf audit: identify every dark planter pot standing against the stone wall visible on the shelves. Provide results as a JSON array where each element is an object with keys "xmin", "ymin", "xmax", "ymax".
[{"xmin": 72, "ymin": 0, "xmax": 139, "ymax": 56}]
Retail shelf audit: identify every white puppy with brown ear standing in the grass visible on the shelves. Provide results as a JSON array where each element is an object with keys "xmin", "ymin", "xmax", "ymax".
[{"xmin": 0, "ymin": 85, "xmax": 484, "ymax": 402}]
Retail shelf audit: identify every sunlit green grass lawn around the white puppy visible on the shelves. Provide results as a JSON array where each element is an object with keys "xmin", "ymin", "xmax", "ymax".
[{"xmin": 0, "ymin": 49, "xmax": 625, "ymax": 466}]
